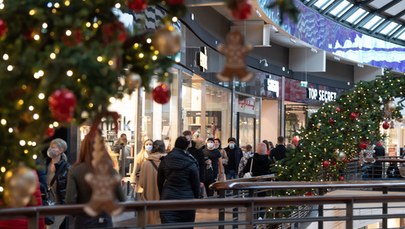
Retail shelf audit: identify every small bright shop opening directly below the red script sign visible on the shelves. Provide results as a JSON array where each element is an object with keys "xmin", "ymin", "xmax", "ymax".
[{"xmin": 236, "ymin": 112, "xmax": 256, "ymax": 148}]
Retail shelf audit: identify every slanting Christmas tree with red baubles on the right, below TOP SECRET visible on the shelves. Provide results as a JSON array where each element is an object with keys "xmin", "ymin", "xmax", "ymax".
[{"xmin": 276, "ymin": 71, "xmax": 405, "ymax": 181}]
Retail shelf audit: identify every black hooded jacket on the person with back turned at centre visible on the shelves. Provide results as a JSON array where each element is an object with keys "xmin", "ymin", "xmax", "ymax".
[{"xmin": 158, "ymin": 148, "xmax": 200, "ymax": 200}]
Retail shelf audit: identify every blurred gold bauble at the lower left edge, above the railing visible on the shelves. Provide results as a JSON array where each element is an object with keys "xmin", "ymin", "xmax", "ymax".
[{"xmin": 3, "ymin": 166, "xmax": 37, "ymax": 207}]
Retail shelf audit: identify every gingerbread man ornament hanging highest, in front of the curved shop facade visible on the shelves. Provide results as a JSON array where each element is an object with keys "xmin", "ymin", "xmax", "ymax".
[{"xmin": 217, "ymin": 30, "xmax": 253, "ymax": 81}]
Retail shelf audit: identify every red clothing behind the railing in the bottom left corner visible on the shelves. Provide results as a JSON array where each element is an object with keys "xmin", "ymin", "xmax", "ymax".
[{"xmin": 0, "ymin": 174, "xmax": 45, "ymax": 229}]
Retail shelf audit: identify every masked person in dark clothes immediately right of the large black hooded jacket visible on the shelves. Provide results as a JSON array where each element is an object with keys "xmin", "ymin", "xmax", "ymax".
[{"xmin": 203, "ymin": 138, "xmax": 225, "ymax": 196}]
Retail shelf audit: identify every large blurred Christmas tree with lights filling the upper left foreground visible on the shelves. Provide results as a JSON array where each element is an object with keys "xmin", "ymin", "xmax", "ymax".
[{"xmin": 0, "ymin": 0, "xmax": 298, "ymax": 206}]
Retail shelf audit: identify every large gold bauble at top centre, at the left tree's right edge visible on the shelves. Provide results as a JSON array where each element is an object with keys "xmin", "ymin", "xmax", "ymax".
[{"xmin": 152, "ymin": 25, "xmax": 181, "ymax": 56}]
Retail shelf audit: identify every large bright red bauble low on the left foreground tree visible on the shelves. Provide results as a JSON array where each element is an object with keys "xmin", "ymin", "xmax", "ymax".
[{"xmin": 48, "ymin": 88, "xmax": 77, "ymax": 122}]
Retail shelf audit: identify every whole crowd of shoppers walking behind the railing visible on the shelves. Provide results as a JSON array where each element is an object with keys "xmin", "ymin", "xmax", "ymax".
[{"xmin": 0, "ymin": 130, "xmax": 296, "ymax": 228}]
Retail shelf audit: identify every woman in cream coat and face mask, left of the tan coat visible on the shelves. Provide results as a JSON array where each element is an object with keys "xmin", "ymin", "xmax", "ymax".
[{"xmin": 130, "ymin": 139, "xmax": 153, "ymax": 199}]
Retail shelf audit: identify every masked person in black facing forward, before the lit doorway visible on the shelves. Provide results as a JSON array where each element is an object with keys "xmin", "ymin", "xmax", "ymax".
[{"xmin": 225, "ymin": 137, "xmax": 243, "ymax": 180}]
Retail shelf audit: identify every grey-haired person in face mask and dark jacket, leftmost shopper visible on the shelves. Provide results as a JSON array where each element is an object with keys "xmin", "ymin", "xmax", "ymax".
[{"xmin": 45, "ymin": 138, "xmax": 70, "ymax": 228}]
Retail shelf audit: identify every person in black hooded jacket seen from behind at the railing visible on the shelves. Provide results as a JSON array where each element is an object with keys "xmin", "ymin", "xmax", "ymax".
[{"xmin": 158, "ymin": 136, "xmax": 200, "ymax": 228}]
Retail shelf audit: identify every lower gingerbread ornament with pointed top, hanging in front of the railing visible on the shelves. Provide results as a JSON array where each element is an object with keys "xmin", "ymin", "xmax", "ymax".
[{"xmin": 84, "ymin": 133, "xmax": 123, "ymax": 216}]
